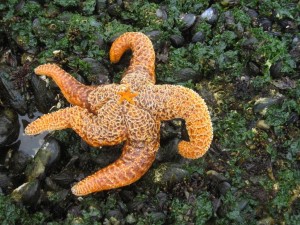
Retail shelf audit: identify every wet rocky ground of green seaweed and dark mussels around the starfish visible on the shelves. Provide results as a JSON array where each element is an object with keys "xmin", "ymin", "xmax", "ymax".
[{"xmin": 0, "ymin": 0, "xmax": 300, "ymax": 224}]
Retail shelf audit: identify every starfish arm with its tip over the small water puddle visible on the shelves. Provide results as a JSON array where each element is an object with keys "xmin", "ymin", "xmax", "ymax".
[{"xmin": 25, "ymin": 102, "xmax": 126, "ymax": 147}]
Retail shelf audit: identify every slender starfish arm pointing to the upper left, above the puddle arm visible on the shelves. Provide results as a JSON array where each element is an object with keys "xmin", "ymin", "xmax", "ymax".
[{"xmin": 34, "ymin": 64, "xmax": 95, "ymax": 107}]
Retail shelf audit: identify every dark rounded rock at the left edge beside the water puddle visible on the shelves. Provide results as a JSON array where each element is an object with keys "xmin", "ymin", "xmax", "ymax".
[{"xmin": 0, "ymin": 107, "xmax": 20, "ymax": 147}]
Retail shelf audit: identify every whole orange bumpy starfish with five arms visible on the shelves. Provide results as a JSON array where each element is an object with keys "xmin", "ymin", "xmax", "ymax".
[{"xmin": 25, "ymin": 32, "xmax": 213, "ymax": 196}]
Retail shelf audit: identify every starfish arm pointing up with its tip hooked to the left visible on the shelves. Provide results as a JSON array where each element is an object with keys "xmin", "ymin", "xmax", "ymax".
[{"xmin": 109, "ymin": 32, "xmax": 155, "ymax": 83}]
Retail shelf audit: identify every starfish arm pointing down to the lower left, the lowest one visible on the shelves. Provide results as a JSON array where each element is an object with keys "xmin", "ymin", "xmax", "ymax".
[{"xmin": 72, "ymin": 141, "xmax": 159, "ymax": 196}]
